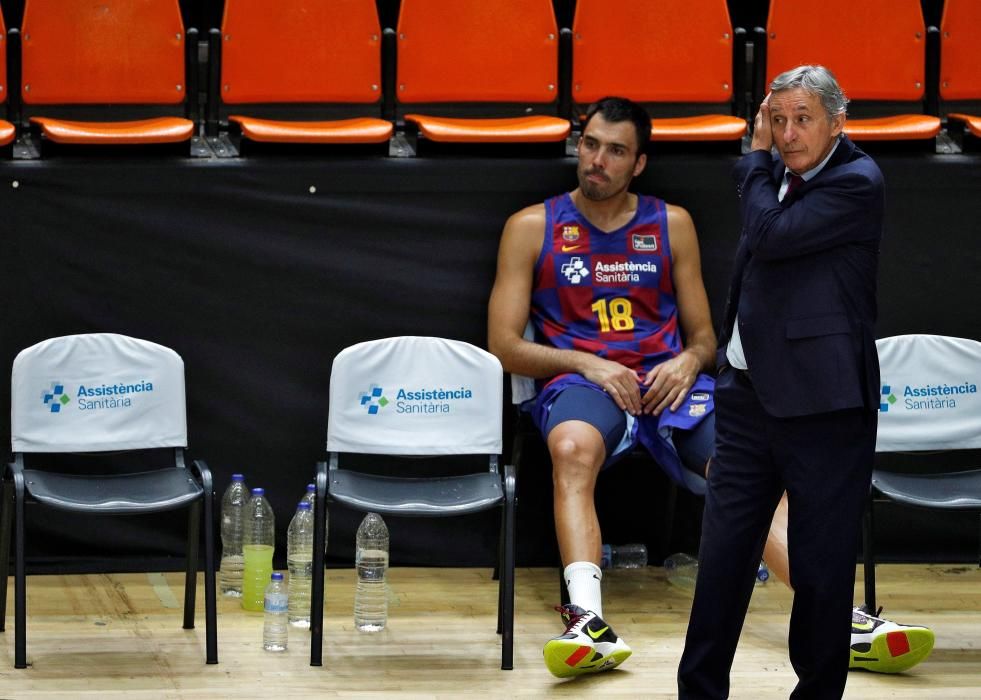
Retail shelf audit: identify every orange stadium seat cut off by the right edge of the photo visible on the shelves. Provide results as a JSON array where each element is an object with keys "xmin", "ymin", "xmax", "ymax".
[{"xmin": 940, "ymin": 0, "xmax": 981, "ymax": 138}]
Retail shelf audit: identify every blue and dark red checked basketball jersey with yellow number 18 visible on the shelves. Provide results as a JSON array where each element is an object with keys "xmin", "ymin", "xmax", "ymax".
[{"xmin": 531, "ymin": 193, "xmax": 682, "ymax": 379}]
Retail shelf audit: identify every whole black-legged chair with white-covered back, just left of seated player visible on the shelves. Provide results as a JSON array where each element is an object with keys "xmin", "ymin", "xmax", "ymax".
[{"xmin": 310, "ymin": 336, "xmax": 515, "ymax": 670}]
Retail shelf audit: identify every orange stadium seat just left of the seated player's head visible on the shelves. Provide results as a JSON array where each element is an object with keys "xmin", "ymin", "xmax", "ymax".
[{"xmin": 396, "ymin": 0, "xmax": 570, "ymax": 150}]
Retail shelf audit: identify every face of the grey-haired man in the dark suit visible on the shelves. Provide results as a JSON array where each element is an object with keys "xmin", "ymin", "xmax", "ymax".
[{"xmin": 770, "ymin": 88, "xmax": 845, "ymax": 175}]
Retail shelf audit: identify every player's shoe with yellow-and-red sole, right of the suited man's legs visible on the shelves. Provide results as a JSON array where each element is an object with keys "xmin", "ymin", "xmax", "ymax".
[{"xmin": 848, "ymin": 608, "xmax": 934, "ymax": 673}]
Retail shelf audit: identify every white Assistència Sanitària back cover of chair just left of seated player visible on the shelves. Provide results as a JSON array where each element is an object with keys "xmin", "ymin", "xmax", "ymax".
[{"xmin": 327, "ymin": 336, "xmax": 503, "ymax": 455}]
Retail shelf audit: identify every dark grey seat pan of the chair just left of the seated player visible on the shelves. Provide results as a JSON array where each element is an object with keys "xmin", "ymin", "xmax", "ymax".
[{"xmin": 328, "ymin": 469, "xmax": 504, "ymax": 516}]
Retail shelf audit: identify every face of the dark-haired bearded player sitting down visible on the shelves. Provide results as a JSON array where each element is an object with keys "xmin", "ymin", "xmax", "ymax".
[{"xmin": 577, "ymin": 114, "xmax": 647, "ymax": 201}]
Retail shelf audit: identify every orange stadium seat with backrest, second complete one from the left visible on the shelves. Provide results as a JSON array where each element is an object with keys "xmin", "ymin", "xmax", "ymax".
[{"xmin": 208, "ymin": 0, "xmax": 393, "ymax": 152}]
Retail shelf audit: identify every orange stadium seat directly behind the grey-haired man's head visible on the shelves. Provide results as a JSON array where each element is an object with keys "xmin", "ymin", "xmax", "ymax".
[{"xmin": 756, "ymin": 0, "xmax": 940, "ymax": 141}]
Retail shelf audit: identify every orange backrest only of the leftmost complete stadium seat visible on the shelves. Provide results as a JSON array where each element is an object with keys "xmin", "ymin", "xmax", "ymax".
[{"xmin": 21, "ymin": 0, "xmax": 187, "ymax": 105}]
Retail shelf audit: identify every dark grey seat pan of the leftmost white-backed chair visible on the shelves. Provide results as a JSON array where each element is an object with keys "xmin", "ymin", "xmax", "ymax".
[{"xmin": 24, "ymin": 469, "xmax": 203, "ymax": 513}]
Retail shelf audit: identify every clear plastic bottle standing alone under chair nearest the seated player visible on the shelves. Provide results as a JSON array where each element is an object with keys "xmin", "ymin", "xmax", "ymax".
[{"xmin": 354, "ymin": 513, "xmax": 388, "ymax": 632}]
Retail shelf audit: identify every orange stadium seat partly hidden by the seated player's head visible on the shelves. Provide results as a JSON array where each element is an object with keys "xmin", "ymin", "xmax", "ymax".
[{"xmin": 572, "ymin": 0, "xmax": 746, "ymax": 141}]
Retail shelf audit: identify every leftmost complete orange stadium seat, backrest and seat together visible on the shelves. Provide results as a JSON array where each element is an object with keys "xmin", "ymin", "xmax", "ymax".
[{"xmin": 21, "ymin": 0, "xmax": 197, "ymax": 144}]
